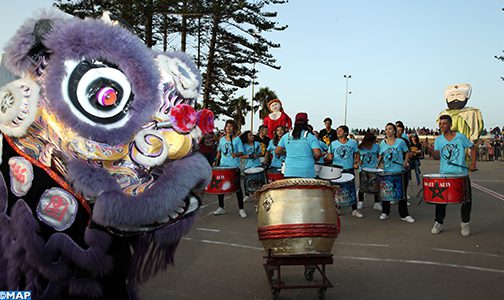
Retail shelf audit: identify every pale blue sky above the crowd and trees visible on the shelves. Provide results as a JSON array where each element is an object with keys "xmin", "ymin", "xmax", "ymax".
[{"xmin": 0, "ymin": 0, "xmax": 504, "ymax": 130}]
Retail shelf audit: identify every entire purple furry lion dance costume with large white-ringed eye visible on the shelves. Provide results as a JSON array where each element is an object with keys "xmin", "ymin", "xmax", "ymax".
[{"xmin": 0, "ymin": 11, "xmax": 213, "ymax": 299}]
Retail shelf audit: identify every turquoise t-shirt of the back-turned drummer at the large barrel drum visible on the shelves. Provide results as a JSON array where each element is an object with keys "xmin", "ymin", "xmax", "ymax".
[{"xmin": 278, "ymin": 130, "xmax": 320, "ymax": 178}]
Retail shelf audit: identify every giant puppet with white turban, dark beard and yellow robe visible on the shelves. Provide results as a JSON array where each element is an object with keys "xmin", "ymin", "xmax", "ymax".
[{"xmin": 437, "ymin": 83, "xmax": 483, "ymax": 142}]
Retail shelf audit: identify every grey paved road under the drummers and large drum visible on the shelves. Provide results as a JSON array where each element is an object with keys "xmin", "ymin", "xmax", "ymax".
[{"xmin": 140, "ymin": 160, "xmax": 504, "ymax": 300}]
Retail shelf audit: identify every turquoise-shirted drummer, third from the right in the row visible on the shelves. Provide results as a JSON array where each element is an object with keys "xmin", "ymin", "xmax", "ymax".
[{"xmin": 357, "ymin": 131, "xmax": 382, "ymax": 211}]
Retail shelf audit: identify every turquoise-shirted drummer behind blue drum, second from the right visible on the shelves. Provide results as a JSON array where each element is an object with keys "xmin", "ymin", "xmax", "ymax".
[{"xmin": 379, "ymin": 123, "xmax": 415, "ymax": 223}]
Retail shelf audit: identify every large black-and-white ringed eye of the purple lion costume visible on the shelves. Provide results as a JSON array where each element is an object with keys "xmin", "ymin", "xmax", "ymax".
[{"xmin": 62, "ymin": 60, "xmax": 133, "ymax": 127}]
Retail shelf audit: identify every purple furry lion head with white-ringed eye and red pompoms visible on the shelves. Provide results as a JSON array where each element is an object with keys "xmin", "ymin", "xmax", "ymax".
[{"xmin": 0, "ymin": 12, "xmax": 213, "ymax": 231}]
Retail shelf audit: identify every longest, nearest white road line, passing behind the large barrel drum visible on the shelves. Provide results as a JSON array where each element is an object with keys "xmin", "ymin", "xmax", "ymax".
[{"xmin": 182, "ymin": 237, "xmax": 504, "ymax": 274}]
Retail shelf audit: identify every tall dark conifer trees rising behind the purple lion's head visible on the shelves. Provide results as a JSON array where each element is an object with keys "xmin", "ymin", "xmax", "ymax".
[{"xmin": 54, "ymin": 0, "xmax": 288, "ymax": 125}]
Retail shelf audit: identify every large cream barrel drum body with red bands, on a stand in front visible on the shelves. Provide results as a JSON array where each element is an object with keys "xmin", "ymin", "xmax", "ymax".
[{"xmin": 257, "ymin": 178, "xmax": 340, "ymax": 255}]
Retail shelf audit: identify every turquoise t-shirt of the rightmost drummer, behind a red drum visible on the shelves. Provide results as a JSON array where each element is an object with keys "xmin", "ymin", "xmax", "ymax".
[{"xmin": 434, "ymin": 132, "xmax": 473, "ymax": 175}]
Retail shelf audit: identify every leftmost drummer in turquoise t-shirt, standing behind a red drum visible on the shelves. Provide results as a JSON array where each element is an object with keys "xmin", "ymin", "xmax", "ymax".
[{"xmin": 214, "ymin": 120, "xmax": 247, "ymax": 218}]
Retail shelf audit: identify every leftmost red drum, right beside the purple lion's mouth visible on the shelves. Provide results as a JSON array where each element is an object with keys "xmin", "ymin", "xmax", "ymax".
[{"xmin": 205, "ymin": 167, "xmax": 240, "ymax": 195}]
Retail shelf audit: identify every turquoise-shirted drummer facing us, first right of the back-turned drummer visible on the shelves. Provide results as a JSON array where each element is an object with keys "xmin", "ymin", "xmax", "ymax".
[{"xmin": 327, "ymin": 125, "xmax": 364, "ymax": 218}]
